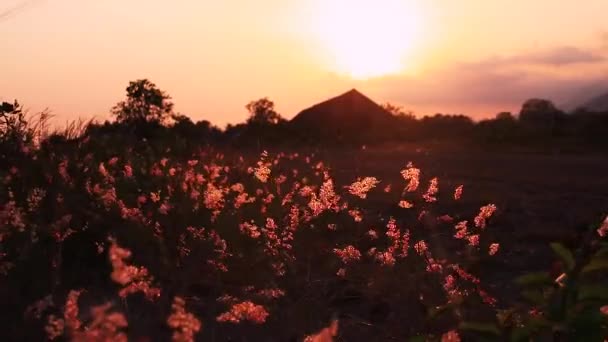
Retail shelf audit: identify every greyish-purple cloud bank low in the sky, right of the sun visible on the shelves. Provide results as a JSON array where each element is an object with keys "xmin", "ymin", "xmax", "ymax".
[{"xmin": 370, "ymin": 48, "xmax": 608, "ymax": 117}]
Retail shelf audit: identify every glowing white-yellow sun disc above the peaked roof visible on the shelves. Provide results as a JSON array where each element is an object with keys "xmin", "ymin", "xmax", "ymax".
[{"xmin": 314, "ymin": 0, "xmax": 421, "ymax": 79}]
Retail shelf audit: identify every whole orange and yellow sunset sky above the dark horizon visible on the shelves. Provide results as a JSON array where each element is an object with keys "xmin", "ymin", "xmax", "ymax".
[{"xmin": 0, "ymin": 0, "xmax": 608, "ymax": 126}]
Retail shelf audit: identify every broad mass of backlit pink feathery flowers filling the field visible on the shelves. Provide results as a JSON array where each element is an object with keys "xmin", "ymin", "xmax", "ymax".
[{"xmin": 0, "ymin": 149, "xmax": 510, "ymax": 341}]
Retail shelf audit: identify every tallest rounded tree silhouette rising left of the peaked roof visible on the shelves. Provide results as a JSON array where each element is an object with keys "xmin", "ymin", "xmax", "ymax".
[{"xmin": 112, "ymin": 79, "xmax": 173, "ymax": 123}]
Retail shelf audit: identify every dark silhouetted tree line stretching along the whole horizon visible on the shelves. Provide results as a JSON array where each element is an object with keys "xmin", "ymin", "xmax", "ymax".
[{"xmin": 0, "ymin": 79, "xmax": 608, "ymax": 153}]
